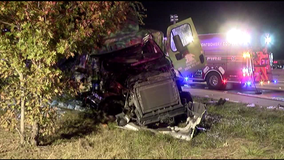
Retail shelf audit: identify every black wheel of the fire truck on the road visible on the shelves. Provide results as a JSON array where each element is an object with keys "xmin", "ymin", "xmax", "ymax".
[{"xmin": 206, "ymin": 72, "xmax": 224, "ymax": 89}]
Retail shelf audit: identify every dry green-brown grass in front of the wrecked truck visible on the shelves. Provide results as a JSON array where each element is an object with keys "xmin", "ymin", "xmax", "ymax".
[{"xmin": 0, "ymin": 97, "xmax": 284, "ymax": 159}]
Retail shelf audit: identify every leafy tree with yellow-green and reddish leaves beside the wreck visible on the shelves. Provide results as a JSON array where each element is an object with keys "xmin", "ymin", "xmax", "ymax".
[{"xmin": 0, "ymin": 1, "xmax": 144, "ymax": 144}]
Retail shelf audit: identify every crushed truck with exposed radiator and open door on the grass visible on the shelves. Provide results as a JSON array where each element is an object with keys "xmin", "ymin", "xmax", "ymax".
[{"xmin": 69, "ymin": 18, "xmax": 206, "ymax": 140}]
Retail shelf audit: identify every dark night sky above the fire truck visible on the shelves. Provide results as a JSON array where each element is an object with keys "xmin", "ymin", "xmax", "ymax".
[{"xmin": 141, "ymin": 1, "xmax": 284, "ymax": 59}]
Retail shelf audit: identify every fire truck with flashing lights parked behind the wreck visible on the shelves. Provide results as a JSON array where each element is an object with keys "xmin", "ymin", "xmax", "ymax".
[{"xmin": 177, "ymin": 33, "xmax": 253, "ymax": 89}]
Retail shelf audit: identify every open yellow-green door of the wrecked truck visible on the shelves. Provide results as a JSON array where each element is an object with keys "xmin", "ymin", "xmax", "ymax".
[{"xmin": 166, "ymin": 18, "xmax": 206, "ymax": 76}]
